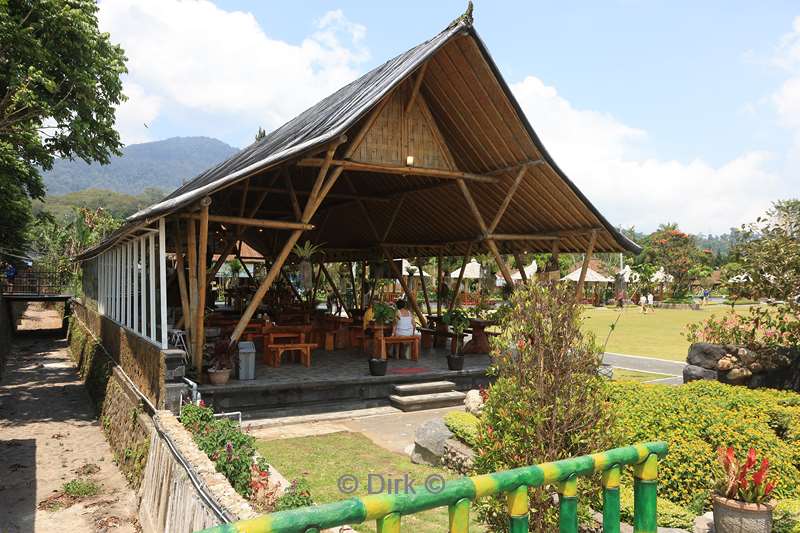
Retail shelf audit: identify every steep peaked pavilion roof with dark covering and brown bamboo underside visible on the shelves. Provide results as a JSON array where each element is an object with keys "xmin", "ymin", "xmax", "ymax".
[{"xmin": 80, "ymin": 10, "xmax": 640, "ymax": 261}]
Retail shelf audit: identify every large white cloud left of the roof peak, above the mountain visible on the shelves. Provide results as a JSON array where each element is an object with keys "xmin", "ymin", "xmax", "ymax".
[{"xmin": 100, "ymin": 0, "xmax": 368, "ymax": 144}]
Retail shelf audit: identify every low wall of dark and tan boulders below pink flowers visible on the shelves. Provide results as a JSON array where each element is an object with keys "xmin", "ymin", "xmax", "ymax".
[{"xmin": 683, "ymin": 342, "xmax": 800, "ymax": 390}]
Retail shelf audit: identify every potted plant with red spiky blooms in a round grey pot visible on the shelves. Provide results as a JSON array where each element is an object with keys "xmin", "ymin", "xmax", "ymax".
[{"xmin": 712, "ymin": 447, "xmax": 775, "ymax": 533}]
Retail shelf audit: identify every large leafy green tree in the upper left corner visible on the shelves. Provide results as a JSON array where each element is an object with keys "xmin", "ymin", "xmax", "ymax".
[{"xmin": 0, "ymin": 0, "xmax": 126, "ymax": 247}]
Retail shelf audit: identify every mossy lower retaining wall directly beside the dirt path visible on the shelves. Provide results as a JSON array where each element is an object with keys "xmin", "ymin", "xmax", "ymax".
[{"xmin": 69, "ymin": 318, "xmax": 152, "ymax": 488}]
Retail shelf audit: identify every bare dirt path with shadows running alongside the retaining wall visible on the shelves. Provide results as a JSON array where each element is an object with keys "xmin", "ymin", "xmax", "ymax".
[{"xmin": 0, "ymin": 304, "xmax": 139, "ymax": 533}]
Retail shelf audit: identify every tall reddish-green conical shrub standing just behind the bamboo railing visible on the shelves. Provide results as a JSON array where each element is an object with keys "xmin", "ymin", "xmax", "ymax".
[{"xmin": 474, "ymin": 283, "xmax": 614, "ymax": 533}]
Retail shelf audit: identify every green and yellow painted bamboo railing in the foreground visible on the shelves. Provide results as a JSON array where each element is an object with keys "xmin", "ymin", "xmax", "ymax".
[{"xmin": 204, "ymin": 442, "xmax": 667, "ymax": 533}]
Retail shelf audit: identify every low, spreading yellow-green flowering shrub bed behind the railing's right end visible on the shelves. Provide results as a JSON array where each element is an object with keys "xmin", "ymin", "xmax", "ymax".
[{"xmin": 609, "ymin": 381, "xmax": 800, "ymax": 511}]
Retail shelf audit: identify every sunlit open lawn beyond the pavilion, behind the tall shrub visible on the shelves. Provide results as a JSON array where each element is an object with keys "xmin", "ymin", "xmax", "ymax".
[{"xmin": 584, "ymin": 305, "xmax": 747, "ymax": 361}]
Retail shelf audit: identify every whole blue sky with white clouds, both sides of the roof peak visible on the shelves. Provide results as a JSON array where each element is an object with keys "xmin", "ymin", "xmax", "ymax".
[{"xmin": 101, "ymin": 0, "xmax": 800, "ymax": 232}]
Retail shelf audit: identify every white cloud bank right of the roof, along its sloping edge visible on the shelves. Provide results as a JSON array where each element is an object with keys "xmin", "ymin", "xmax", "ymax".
[{"xmin": 512, "ymin": 76, "xmax": 780, "ymax": 233}]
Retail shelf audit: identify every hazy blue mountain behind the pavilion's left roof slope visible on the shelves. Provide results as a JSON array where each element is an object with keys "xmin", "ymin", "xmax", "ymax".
[{"xmin": 44, "ymin": 137, "xmax": 239, "ymax": 195}]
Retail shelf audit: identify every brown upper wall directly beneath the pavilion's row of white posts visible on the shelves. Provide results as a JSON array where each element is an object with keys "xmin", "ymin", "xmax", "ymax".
[{"xmin": 73, "ymin": 301, "xmax": 166, "ymax": 408}]
